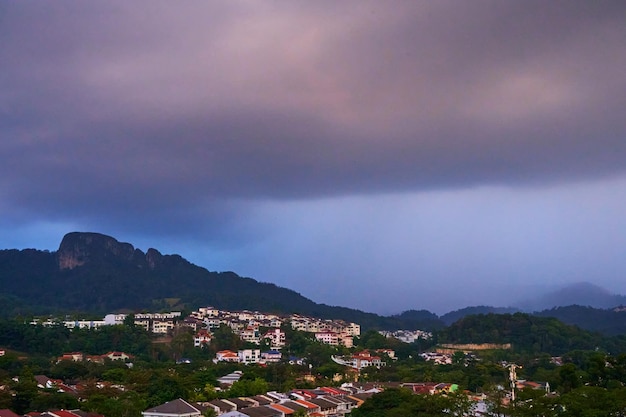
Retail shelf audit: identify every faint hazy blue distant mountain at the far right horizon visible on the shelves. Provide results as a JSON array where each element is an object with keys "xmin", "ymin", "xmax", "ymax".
[{"xmin": 516, "ymin": 282, "xmax": 626, "ymax": 311}]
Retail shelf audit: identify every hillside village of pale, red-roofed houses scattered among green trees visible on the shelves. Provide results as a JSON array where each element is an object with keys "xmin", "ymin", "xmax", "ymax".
[{"xmin": 6, "ymin": 307, "xmax": 626, "ymax": 417}]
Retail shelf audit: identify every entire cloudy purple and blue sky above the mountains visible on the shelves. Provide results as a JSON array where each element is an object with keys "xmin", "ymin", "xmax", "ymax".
[{"xmin": 0, "ymin": 0, "xmax": 626, "ymax": 314}]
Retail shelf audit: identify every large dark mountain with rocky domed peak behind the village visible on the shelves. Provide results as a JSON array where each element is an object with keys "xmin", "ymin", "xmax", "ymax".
[{"xmin": 0, "ymin": 232, "xmax": 442, "ymax": 330}]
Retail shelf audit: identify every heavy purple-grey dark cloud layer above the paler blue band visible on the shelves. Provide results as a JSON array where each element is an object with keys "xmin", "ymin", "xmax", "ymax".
[{"xmin": 0, "ymin": 0, "xmax": 626, "ymax": 310}]
